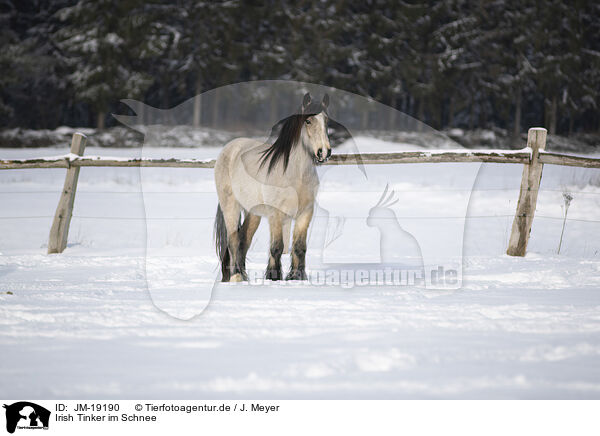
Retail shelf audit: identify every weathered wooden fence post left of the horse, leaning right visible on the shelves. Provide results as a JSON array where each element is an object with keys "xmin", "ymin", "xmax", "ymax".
[{"xmin": 48, "ymin": 133, "xmax": 86, "ymax": 254}]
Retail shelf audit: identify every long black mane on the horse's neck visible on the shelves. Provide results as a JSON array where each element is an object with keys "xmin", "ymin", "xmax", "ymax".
[{"xmin": 260, "ymin": 102, "xmax": 324, "ymax": 173}]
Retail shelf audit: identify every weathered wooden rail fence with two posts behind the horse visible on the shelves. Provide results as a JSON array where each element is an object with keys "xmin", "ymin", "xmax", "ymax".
[{"xmin": 0, "ymin": 127, "xmax": 600, "ymax": 256}]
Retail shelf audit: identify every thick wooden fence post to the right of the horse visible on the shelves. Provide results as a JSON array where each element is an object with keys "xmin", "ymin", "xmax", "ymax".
[{"xmin": 506, "ymin": 127, "xmax": 547, "ymax": 256}]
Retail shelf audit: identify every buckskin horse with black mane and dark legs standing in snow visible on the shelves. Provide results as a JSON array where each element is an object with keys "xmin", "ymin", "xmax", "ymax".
[{"xmin": 214, "ymin": 93, "xmax": 331, "ymax": 282}]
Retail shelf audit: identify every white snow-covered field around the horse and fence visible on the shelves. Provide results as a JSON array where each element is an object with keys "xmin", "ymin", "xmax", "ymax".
[{"xmin": 0, "ymin": 138, "xmax": 600, "ymax": 399}]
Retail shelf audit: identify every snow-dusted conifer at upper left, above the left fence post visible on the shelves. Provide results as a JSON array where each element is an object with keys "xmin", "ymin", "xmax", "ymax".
[{"xmin": 53, "ymin": 0, "xmax": 157, "ymax": 128}]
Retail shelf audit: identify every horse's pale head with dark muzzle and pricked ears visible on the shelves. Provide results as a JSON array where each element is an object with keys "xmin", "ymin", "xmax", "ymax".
[{"xmin": 300, "ymin": 92, "xmax": 331, "ymax": 163}]
